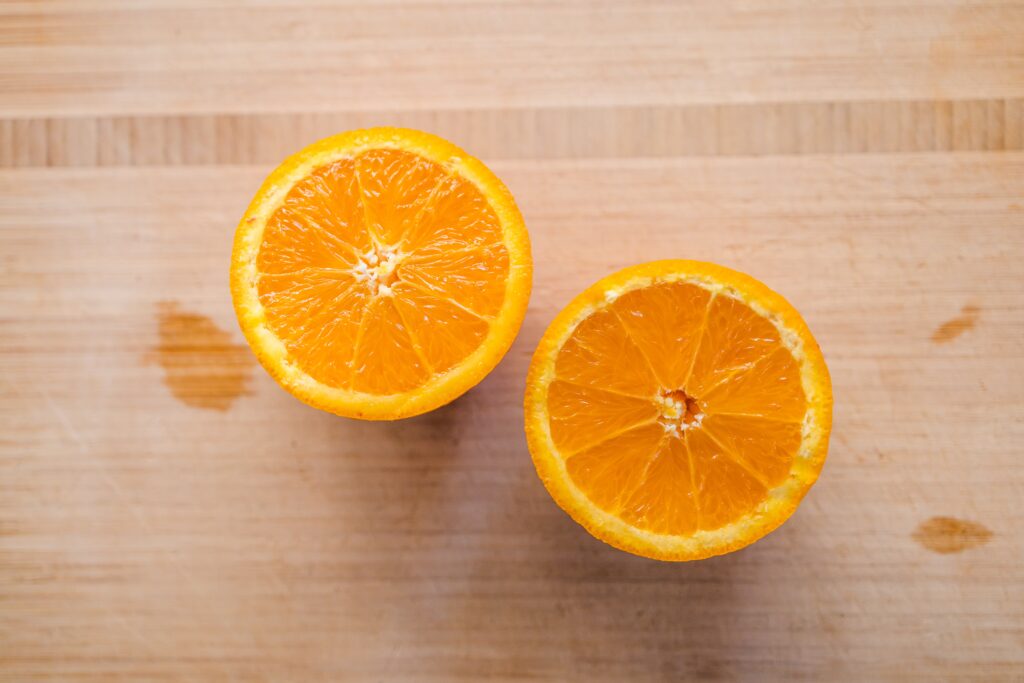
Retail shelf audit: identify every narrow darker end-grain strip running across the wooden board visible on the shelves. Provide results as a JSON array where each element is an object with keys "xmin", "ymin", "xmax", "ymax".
[{"xmin": 0, "ymin": 98, "xmax": 1024, "ymax": 167}]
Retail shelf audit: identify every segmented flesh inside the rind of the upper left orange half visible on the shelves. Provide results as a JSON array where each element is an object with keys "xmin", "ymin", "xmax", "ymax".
[{"xmin": 256, "ymin": 148, "xmax": 509, "ymax": 395}]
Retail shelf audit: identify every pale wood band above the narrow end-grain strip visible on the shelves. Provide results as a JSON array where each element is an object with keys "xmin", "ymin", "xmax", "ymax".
[{"xmin": 0, "ymin": 0, "xmax": 1024, "ymax": 115}]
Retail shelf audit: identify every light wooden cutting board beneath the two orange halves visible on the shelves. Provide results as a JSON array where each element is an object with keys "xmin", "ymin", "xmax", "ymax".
[{"xmin": 0, "ymin": 0, "xmax": 1024, "ymax": 682}]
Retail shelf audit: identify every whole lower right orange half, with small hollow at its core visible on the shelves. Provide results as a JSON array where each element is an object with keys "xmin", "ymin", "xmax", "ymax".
[{"xmin": 525, "ymin": 261, "xmax": 831, "ymax": 560}]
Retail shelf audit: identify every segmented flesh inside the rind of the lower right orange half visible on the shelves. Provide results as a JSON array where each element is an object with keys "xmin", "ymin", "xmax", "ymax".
[{"xmin": 548, "ymin": 283, "xmax": 807, "ymax": 535}]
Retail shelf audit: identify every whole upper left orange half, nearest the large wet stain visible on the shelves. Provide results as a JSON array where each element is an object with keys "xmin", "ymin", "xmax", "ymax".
[{"xmin": 231, "ymin": 128, "xmax": 531, "ymax": 420}]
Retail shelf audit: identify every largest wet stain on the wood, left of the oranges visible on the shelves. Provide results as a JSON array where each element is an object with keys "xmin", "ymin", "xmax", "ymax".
[{"xmin": 146, "ymin": 301, "xmax": 254, "ymax": 411}]
